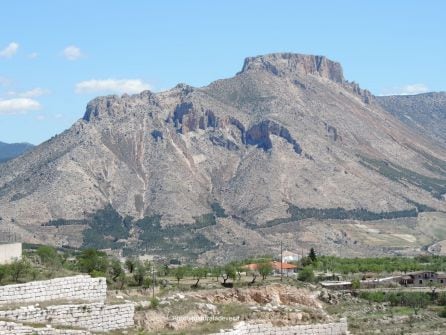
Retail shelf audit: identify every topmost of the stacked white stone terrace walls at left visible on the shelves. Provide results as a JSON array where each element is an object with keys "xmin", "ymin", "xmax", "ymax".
[{"xmin": 0, "ymin": 275, "xmax": 107, "ymax": 305}]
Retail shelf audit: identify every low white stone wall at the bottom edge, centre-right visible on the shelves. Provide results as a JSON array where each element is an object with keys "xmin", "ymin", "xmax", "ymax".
[{"xmin": 212, "ymin": 319, "xmax": 348, "ymax": 335}]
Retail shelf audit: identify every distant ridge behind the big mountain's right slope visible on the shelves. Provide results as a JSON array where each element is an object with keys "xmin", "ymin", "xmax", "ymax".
[{"xmin": 376, "ymin": 92, "xmax": 446, "ymax": 144}]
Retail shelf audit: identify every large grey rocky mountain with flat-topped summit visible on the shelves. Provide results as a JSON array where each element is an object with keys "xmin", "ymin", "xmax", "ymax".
[{"xmin": 0, "ymin": 53, "xmax": 446, "ymax": 262}]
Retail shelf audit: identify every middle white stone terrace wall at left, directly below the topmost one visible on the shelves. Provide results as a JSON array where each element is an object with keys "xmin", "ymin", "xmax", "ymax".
[{"xmin": 0, "ymin": 303, "xmax": 135, "ymax": 331}]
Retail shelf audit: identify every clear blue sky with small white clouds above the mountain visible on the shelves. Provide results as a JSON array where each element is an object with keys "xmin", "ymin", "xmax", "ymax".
[{"xmin": 0, "ymin": 0, "xmax": 446, "ymax": 144}]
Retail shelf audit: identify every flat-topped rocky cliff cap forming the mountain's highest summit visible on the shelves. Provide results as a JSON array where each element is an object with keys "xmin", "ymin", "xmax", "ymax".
[{"xmin": 239, "ymin": 53, "xmax": 344, "ymax": 83}]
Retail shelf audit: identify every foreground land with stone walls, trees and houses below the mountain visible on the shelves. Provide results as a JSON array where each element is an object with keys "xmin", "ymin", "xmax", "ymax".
[{"xmin": 0, "ymin": 243, "xmax": 446, "ymax": 335}]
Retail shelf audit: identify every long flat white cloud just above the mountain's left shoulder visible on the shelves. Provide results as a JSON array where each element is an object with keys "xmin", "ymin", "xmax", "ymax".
[{"xmin": 75, "ymin": 79, "xmax": 150, "ymax": 93}]
